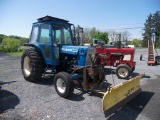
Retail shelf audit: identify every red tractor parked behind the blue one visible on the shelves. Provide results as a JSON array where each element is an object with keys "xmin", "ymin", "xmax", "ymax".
[{"xmin": 95, "ymin": 36, "xmax": 136, "ymax": 79}]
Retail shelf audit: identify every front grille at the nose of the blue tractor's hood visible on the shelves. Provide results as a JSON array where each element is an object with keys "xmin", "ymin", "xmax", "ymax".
[{"xmin": 85, "ymin": 47, "xmax": 96, "ymax": 66}]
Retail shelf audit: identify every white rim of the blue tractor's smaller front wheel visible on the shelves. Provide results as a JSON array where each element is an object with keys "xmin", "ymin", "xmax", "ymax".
[{"xmin": 56, "ymin": 78, "xmax": 66, "ymax": 93}]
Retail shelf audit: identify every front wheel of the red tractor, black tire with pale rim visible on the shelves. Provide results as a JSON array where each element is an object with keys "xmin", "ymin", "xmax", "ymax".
[{"xmin": 116, "ymin": 64, "xmax": 132, "ymax": 79}]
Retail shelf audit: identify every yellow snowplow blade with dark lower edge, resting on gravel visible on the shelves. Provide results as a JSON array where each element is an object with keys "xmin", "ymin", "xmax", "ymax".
[{"xmin": 102, "ymin": 74, "xmax": 144, "ymax": 117}]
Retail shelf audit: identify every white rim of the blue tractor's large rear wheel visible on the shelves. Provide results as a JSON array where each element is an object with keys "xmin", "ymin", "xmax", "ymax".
[{"xmin": 23, "ymin": 56, "xmax": 32, "ymax": 77}]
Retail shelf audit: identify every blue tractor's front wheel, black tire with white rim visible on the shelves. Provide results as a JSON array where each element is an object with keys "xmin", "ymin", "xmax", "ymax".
[{"xmin": 54, "ymin": 72, "xmax": 74, "ymax": 98}]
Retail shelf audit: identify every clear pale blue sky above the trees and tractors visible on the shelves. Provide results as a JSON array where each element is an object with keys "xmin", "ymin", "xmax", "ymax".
[{"xmin": 0, "ymin": 0, "xmax": 160, "ymax": 39}]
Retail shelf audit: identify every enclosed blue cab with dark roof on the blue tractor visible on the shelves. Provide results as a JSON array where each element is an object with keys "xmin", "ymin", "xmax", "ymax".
[{"xmin": 29, "ymin": 16, "xmax": 76, "ymax": 65}]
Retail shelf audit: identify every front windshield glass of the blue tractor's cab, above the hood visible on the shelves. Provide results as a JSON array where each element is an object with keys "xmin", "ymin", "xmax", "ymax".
[{"xmin": 52, "ymin": 24, "xmax": 73, "ymax": 45}]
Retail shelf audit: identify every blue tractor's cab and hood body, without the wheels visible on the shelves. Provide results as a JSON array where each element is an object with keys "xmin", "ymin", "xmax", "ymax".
[{"xmin": 25, "ymin": 16, "xmax": 95, "ymax": 72}]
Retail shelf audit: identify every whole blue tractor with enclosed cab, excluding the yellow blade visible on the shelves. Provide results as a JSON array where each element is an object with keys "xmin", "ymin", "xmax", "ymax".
[{"xmin": 21, "ymin": 16, "xmax": 107, "ymax": 98}]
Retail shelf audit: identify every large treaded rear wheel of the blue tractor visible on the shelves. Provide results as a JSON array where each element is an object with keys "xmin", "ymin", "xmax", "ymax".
[{"xmin": 21, "ymin": 48, "xmax": 45, "ymax": 82}]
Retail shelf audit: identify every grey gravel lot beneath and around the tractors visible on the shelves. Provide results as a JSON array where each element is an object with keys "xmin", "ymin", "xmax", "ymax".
[{"xmin": 0, "ymin": 49, "xmax": 160, "ymax": 120}]
